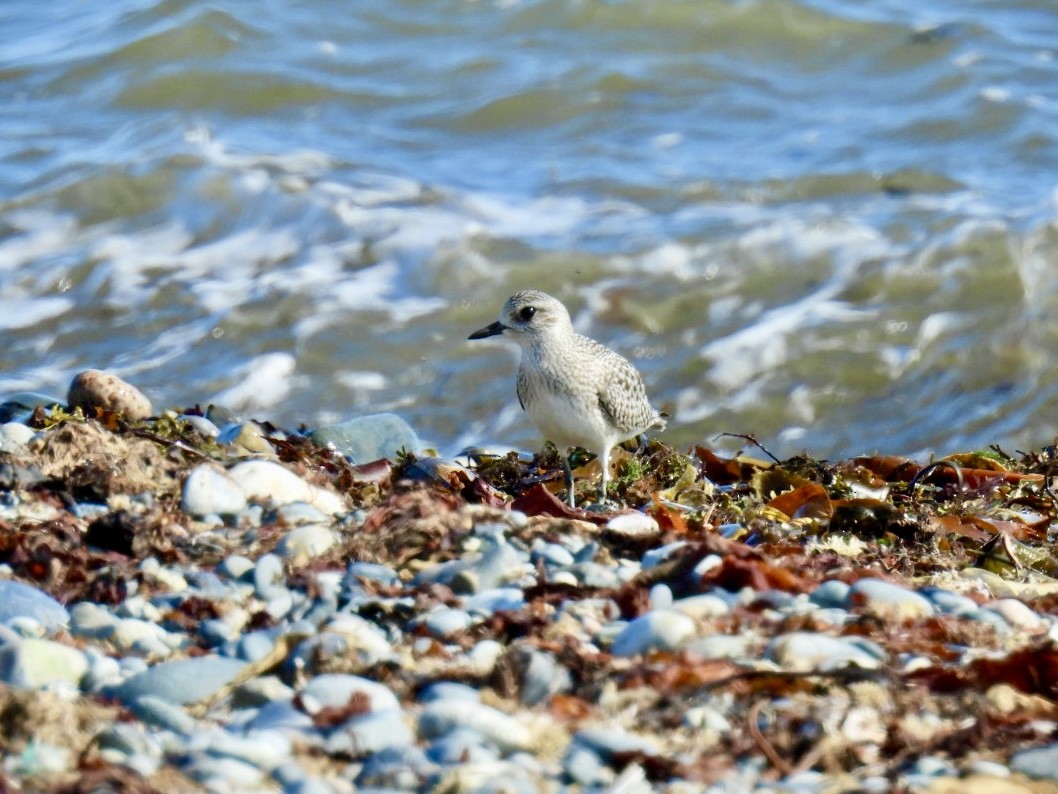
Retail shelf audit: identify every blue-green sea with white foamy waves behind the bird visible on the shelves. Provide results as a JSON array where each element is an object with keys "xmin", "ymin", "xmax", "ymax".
[{"xmin": 0, "ymin": 0, "xmax": 1058, "ymax": 456}]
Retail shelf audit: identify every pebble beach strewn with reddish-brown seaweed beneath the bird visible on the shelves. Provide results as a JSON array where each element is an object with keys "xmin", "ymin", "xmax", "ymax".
[{"xmin": 0, "ymin": 371, "xmax": 1058, "ymax": 794}]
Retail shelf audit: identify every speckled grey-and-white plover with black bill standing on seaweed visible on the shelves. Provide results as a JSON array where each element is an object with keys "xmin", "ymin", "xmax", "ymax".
[{"xmin": 469, "ymin": 289, "xmax": 665, "ymax": 506}]
